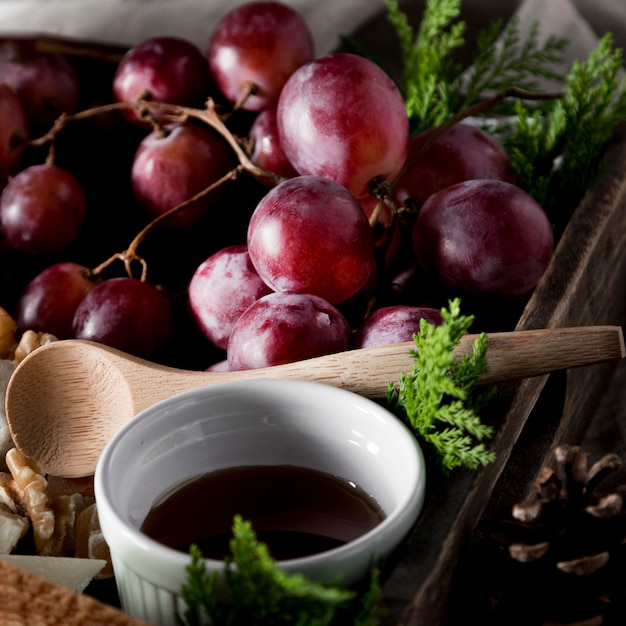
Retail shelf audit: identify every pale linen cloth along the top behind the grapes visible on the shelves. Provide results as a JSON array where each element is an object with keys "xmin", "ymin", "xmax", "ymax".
[{"xmin": 0, "ymin": 0, "xmax": 626, "ymax": 64}]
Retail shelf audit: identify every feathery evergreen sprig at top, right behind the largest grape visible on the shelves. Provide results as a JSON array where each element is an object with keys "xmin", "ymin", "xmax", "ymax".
[{"xmin": 385, "ymin": 0, "xmax": 567, "ymax": 134}]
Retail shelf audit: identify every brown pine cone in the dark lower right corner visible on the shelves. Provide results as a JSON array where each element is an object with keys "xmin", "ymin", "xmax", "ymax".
[{"xmin": 482, "ymin": 446, "xmax": 626, "ymax": 626}]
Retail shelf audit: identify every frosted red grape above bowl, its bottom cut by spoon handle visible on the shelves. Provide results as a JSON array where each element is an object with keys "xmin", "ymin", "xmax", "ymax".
[{"xmin": 227, "ymin": 293, "xmax": 350, "ymax": 371}]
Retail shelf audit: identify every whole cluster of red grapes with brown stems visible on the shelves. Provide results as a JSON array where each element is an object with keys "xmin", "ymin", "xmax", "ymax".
[{"xmin": 0, "ymin": 1, "xmax": 554, "ymax": 370}]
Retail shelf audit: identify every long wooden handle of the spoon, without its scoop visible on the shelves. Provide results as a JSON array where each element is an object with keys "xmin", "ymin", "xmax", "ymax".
[{"xmin": 135, "ymin": 326, "xmax": 626, "ymax": 400}]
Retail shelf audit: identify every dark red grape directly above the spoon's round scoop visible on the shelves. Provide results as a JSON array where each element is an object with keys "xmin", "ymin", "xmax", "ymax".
[{"xmin": 15, "ymin": 261, "xmax": 100, "ymax": 339}]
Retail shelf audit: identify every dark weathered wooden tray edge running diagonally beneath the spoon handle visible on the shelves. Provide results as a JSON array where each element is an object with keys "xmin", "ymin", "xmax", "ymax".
[{"xmin": 382, "ymin": 124, "xmax": 626, "ymax": 626}]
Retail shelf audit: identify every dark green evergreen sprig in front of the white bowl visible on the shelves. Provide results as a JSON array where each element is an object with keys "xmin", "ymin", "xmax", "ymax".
[{"xmin": 176, "ymin": 516, "xmax": 380, "ymax": 626}]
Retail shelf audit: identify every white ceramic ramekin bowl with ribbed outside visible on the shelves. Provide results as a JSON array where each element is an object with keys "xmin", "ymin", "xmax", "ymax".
[{"xmin": 95, "ymin": 380, "xmax": 425, "ymax": 625}]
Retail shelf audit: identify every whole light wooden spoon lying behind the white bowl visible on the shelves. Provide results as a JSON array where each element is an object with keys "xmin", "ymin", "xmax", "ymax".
[{"xmin": 6, "ymin": 326, "xmax": 625, "ymax": 477}]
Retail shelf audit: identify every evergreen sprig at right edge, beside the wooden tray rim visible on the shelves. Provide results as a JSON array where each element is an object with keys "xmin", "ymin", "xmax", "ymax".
[{"xmin": 504, "ymin": 34, "xmax": 626, "ymax": 219}]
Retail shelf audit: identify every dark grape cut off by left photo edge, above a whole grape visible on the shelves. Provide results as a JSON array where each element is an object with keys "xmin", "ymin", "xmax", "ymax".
[{"xmin": 0, "ymin": 83, "xmax": 29, "ymax": 181}]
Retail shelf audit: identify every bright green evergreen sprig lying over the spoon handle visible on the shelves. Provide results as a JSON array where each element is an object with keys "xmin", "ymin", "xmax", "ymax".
[{"xmin": 387, "ymin": 299, "xmax": 495, "ymax": 472}]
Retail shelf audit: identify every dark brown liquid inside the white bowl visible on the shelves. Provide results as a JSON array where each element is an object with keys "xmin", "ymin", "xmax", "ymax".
[{"xmin": 141, "ymin": 465, "xmax": 385, "ymax": 560}]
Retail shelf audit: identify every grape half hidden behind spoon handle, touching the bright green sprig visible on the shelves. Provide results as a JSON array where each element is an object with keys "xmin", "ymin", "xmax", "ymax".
[{"xmin": 352, "ymin": 305, "xmax": 443, "ymax": 348}]
